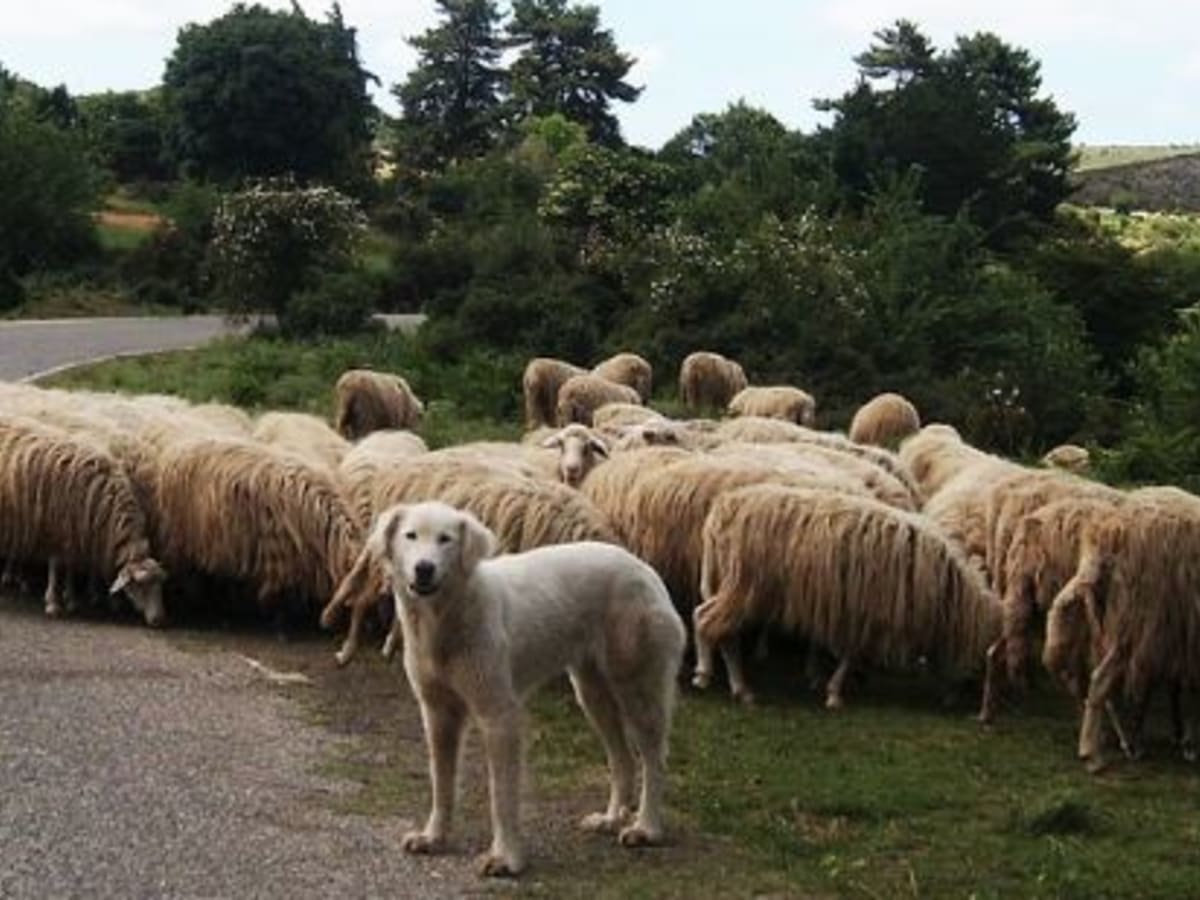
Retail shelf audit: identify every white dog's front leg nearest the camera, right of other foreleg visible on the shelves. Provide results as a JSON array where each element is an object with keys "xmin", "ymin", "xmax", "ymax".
[{"xmin": 479, "ymin": 704, "xmax": 524, "ymax": 877}]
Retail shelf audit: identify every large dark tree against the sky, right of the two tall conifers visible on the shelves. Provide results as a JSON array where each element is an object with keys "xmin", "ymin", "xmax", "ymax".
[{"xmin": 817, "ymin": 20, "xmax": 1075, "ymax": 246}]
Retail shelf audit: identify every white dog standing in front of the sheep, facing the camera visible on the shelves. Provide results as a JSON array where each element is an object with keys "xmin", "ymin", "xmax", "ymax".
[{"xmin": 368, "ymin": 503, "xmax": 685, "ymax": 875}]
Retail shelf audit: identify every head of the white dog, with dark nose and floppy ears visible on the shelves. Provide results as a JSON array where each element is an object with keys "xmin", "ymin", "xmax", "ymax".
[{"xmin": 368, "ymin": 500, "xmax": 496, "ymax": 598}]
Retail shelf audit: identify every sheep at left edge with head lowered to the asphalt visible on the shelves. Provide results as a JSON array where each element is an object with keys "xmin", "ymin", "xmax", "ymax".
[{"xmin": 0, "ymin": 416, "xmax": 166, "ymax": 626}]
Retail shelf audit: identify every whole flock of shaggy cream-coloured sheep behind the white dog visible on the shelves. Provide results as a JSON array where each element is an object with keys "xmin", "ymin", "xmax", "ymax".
[{"xmin": 0, "ymin": 352, "xmax": 1200, "ymax": 769}]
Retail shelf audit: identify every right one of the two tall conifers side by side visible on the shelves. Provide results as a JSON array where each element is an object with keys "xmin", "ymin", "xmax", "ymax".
[{"xmin": 506, "ymin": 0, "xmax": 642, "ymax": 146}]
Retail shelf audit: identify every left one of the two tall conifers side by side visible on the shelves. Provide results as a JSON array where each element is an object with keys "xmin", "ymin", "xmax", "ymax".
[{"xmin": 392, "ymin": 0, "xmax": 505, "ymax": 169}]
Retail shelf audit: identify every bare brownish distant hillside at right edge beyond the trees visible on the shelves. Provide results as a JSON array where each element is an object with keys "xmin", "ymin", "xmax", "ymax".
[{"xmin": 1070, "ymin": 148, "xmax": 1200, "ymax": 212}]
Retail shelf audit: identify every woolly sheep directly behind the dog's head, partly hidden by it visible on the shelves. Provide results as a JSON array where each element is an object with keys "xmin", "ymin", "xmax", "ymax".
[{"xmin": 320, "ymin": 454, "xmax": 620, "ymax": 665}]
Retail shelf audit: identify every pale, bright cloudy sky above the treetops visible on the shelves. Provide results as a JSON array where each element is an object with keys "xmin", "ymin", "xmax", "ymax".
[{"xmin": 0, "ymin": 0, "xmax": 1200, "ymax": 148}]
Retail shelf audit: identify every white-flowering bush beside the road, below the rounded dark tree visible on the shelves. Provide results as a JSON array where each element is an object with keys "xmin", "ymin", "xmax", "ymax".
[{"xmin": 210, "ymin": 180, "xmax": 366, "ymax": 316}]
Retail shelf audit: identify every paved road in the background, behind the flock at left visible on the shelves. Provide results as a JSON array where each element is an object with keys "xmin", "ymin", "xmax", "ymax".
[{"xmin": 0, "ymin": 316, "xmax": 424, "ymax": 380}]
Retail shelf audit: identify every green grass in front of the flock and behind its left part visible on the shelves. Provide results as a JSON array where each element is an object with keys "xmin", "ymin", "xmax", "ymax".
[{"xmin": 55, "ymin": 335, "xmax": 1200, "ymax": 899}]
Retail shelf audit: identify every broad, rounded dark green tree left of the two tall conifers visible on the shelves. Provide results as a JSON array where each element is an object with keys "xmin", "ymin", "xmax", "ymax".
[{"xmin": 163, "ymin": 4, "xmax": 373, "ymax": 186}]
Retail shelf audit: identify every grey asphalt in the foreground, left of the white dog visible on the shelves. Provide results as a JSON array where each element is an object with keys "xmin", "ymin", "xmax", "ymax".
[{"xmin": 0, "ymin": 607, "xmax": 480, "ymax": 898}]
